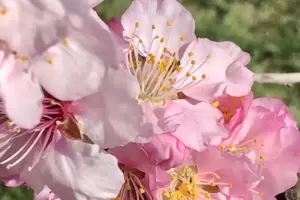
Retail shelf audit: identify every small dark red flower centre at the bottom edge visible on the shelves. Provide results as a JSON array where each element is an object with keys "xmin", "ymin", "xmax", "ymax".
[{"xmin": 113, "ymin": 165, "xmax": 152, "ymax": 200}]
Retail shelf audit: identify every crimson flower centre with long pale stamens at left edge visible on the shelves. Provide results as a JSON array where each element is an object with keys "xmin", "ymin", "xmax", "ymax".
[{"xmin": 0, "ymin": 98, "xmax": 81, "ymax": 171}]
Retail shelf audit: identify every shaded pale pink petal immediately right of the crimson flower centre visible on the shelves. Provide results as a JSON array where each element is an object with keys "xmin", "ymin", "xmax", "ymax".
[{"xmin": 73, "ymin": 68, "xmax": 143, "ymax": 148}]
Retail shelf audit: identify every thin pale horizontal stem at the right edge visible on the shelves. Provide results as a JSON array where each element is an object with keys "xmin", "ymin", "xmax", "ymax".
[{"xmin": 254, "ymin": 73, "xmax": 300, "ymax": 84}]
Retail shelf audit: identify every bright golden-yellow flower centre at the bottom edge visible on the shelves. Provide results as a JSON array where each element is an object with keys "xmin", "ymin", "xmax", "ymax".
[{"xmin": 162, "ymin": 166, "xmax": 232, "ymax": 200}]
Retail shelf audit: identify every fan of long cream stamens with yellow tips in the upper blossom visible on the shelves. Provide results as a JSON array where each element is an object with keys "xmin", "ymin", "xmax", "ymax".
[{"xmin": 126, "ymin": 21, "xmax": 211, "ymax": 105}]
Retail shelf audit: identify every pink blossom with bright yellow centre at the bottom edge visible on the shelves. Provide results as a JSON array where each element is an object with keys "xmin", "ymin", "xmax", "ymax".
[{"xmin": 156, "ymin": 148, "xmax": 257, "ymax": 200}]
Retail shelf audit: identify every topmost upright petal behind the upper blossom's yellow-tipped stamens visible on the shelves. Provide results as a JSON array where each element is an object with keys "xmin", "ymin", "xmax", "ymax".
[{"xmin": 121, "ymin": 0, "xmax": 195, "ymax": 52}]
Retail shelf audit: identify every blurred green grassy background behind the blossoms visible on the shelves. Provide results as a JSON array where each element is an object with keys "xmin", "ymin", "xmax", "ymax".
[{"xmin": 0, "ymin": 0, "xmax": 300, "ymax": 200}]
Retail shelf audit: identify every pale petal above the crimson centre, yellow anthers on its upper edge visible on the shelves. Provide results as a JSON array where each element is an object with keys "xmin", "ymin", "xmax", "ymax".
[{"xmin": 32, "ymin": 13, "xmax": 119, "ymax": 100}]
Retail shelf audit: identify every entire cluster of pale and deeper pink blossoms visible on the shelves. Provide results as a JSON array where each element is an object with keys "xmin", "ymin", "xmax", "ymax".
[{"xmin": 0, "ymin": 0, "xmax": 300, "ymax": 200}]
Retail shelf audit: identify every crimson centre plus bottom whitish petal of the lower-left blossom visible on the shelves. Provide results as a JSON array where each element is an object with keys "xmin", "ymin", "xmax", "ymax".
[{"xmin": 0, "ymin": 97, "xmax": 124, "ymax": 200}]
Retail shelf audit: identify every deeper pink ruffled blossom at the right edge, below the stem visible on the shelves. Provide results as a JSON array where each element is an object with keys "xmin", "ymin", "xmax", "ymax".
[{"xmin": 220, "ymin": 98, "xmax": 300, "ymax": 199}]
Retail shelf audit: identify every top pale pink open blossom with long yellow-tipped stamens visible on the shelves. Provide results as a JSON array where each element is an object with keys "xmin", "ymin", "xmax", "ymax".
[{"xmin": 88, "ymin": 0, "xmax": 236, "ymax": 150}]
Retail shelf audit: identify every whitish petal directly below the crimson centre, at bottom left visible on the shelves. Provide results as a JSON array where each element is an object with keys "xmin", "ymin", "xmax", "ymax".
[{"xmin": 25, "ymin": 140, "xmax": 124, "ymax": 200}]
